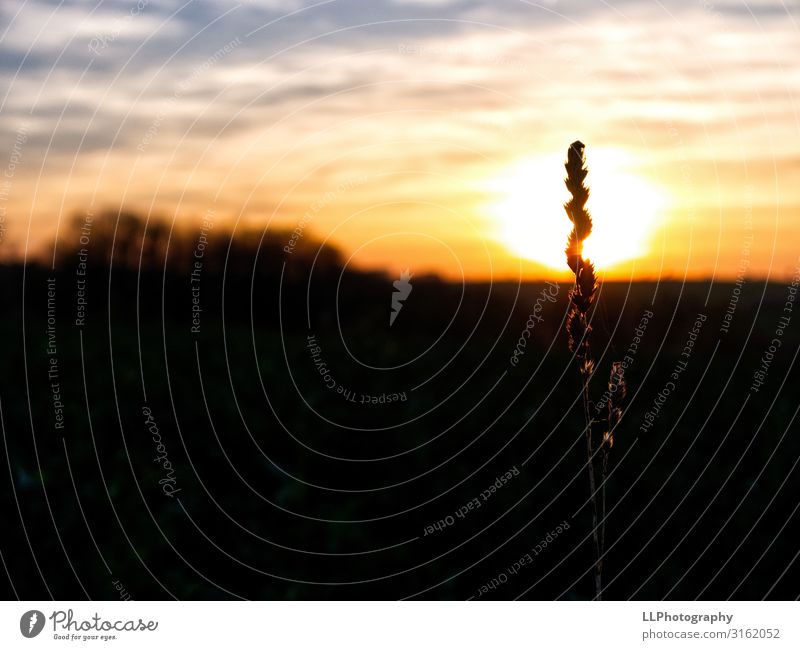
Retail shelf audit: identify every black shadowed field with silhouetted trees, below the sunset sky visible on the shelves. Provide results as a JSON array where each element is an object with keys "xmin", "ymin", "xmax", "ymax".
[{"xmin": 0, "ymin": 220, "xmax": 800, "ymax": 599}]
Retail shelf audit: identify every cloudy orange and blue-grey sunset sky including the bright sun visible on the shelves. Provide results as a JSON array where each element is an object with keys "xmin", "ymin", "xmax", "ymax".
[{"xmin": 0, "ymin": 0, "xmax": 800, "ymax": 280}]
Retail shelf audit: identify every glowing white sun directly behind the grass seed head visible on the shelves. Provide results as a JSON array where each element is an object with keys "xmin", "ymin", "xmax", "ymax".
[{"xmin": 486, "ymin": 149, "xmax": 665, "ymax": 270}]
